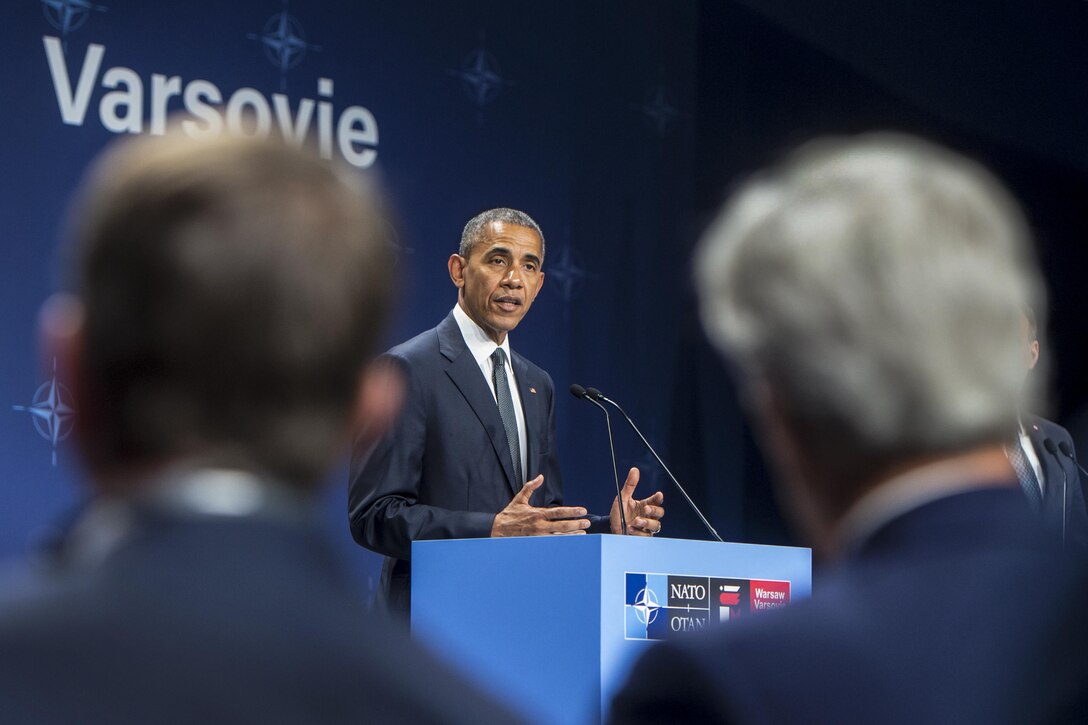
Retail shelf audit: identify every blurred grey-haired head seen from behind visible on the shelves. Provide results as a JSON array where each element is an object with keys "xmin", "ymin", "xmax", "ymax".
[{"xmin": 695, "ymin": 134, "xmax": 1042, "ymax": 548}]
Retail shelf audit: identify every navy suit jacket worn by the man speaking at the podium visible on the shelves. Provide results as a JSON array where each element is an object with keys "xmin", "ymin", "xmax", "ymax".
[{"xmin": 348, "ymin": 314, "xmax": 607, "ymax": 612}]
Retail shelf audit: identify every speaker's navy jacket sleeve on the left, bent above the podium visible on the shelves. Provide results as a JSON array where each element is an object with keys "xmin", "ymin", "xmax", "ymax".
[{"xmin": 348, "ymin": 355, "xmax": 495, "ymax": 560}]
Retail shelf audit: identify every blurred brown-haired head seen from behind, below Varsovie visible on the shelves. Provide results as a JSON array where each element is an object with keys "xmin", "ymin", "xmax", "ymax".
[{"xmin": 42, "ymin": 134, "xmax": 391, "ymax": 493}]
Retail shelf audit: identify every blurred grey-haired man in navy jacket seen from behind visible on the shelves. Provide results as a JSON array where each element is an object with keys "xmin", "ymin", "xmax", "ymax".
[{"xmin": 613, "ymin": 134, "xmax": 1088, "ymax": 724}]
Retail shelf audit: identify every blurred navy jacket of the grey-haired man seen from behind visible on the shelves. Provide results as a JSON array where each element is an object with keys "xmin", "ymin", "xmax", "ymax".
[{"xmin": 611, "ymin": 488, "xmax": 1088, "ymax": 724}]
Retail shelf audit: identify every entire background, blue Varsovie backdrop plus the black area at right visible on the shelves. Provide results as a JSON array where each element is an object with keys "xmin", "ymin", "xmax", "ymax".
[{"xmin": 6, "ymin": 0, "xmax": 1088, "ymax": 592}]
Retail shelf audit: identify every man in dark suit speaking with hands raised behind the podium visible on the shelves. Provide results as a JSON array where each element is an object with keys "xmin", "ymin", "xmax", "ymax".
[{"xmin": 348, "ymin": 208, "xmax": 665, "ymax": 613}]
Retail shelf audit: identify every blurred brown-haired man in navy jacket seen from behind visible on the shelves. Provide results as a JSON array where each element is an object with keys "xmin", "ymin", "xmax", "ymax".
[{"xmin": 0, "ymin": 134, "xmax": 510, "ymax": 725}]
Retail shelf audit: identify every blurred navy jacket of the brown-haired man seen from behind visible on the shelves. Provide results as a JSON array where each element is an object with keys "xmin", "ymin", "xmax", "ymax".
[{"xmin": 0, "ymin": 502, "xmax": 522, "ymax": 725}]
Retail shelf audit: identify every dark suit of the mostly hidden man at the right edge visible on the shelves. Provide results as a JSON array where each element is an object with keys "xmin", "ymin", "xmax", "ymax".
[{"xmin": 1024, "ymin": 416, "xmax": 1088, "ymax": 549}]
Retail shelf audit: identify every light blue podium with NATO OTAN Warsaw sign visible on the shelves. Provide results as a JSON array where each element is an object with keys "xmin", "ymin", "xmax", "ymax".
[{"xmin": 411, "ymin": 534, "xmax": 812, "ymax": 723}]
